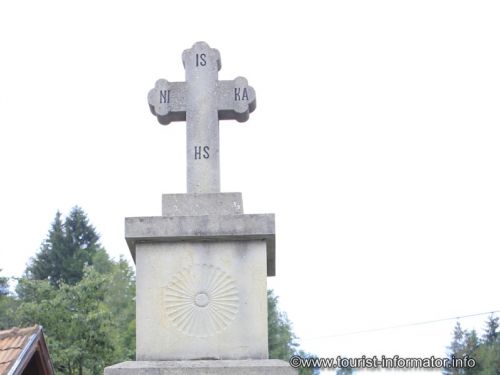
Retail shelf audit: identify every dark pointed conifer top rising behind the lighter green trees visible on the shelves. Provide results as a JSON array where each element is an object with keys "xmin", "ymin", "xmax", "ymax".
[{"xmin": 26, "ymin": 206, "xmax": 101, "ymax": 286}]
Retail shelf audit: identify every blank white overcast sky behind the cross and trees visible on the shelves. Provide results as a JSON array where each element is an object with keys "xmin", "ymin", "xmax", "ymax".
[{"xmin": 0, "ymin": 0, "xmax": 500, "ymax": 374}]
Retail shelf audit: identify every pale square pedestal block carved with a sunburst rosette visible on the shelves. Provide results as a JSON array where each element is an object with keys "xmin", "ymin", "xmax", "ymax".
[{"xmin": 136, "ymin": 240, "xmax": 268, "ymax": 360}]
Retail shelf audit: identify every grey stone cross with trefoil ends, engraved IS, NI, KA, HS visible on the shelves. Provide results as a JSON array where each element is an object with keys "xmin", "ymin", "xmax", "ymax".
[{"xmin": 148, "ymin": 42, "xmax": 256, "ymax": 193}]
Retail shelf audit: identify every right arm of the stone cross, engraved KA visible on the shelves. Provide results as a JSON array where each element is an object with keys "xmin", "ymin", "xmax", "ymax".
[{"xmin": 217, "ymin": 77, "xmax": 256, "ymax": 122}]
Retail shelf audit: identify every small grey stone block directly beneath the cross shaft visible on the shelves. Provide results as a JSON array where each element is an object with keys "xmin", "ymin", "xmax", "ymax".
[{"xmin": 162, "ymin": 193, "xmax": 243, "ymax": 216}]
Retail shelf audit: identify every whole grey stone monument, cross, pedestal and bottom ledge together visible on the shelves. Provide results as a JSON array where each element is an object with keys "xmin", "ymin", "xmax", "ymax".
[{"xmin": 105, "ymin": 42, "xmax": 296, "ymax": 375}]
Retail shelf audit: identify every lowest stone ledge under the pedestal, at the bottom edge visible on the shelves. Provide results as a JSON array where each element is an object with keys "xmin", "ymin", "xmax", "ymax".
[{"xmin": 104, "ymin": 359, "xmax": 297, "ymax": 375}]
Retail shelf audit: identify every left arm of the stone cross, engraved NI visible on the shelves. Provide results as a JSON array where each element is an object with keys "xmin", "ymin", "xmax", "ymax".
[{"xmin": 148, "ymin": 79, "xmax": 187, "ymax": 125}]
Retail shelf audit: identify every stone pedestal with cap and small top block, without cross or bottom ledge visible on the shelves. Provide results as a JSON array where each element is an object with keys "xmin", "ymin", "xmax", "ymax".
[{"xmin": 125, "ymin": 193, "xmax": 275, "ymax": 361}]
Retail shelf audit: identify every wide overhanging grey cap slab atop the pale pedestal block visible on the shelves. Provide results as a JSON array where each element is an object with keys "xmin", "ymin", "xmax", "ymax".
[{"xmin": 125, "ymin": 214, "xmax": 276, "ymax": 276}]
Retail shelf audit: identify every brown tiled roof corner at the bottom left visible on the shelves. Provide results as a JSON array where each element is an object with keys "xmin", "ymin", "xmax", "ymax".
[{"xmin": 0, "ymin": 325, "xmax": 54, "ymax": 375}]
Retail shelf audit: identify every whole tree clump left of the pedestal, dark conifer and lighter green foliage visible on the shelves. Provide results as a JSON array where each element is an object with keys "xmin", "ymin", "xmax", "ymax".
[{"xmin": 9, "ymin": 207, "xmax": 135, "ymax": 375}]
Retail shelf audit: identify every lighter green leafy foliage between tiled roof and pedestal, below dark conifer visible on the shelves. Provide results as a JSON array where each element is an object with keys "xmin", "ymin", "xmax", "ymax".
[{"xmin": 16, "ymin": 259, "xmax": 135, "ymax": 375}]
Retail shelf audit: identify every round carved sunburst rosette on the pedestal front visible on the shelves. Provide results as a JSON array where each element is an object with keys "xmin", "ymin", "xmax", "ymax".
[{"xmin": 163, "ymin": 264, "xmax": 239, "ymax": 337}]
